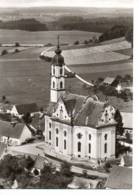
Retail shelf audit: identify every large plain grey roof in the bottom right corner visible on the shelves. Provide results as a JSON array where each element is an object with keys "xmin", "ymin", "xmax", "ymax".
[{"xmin": 106, "ymin": 166, "xmax": 132, "ymax": 189}]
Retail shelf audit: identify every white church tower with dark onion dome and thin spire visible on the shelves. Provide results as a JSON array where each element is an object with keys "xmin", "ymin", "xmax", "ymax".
[{"xmin": 50, "ymin": 36, "xmax": 65, "ymax": 103}]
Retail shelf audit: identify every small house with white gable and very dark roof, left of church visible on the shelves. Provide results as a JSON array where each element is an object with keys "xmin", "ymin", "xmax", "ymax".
[{"xmin": 11, "ymin": 103, "xmax": 39, "ymax": 117}]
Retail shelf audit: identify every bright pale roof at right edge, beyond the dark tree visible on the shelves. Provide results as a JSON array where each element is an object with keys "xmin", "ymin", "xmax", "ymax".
[{"xmin": 121, "ymin": 112, "xmax": 133, "ymax": 129}]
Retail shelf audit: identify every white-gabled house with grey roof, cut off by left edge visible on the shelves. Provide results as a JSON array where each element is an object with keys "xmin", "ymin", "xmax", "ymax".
[{"xmin": 0, "ymin": 120, "xmax": 32, "ymax": 146}]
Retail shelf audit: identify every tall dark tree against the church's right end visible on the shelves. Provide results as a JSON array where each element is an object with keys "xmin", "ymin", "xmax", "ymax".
[{"xmin": 114, "ymin": 109, "xmax": 124, "ymax": 135}]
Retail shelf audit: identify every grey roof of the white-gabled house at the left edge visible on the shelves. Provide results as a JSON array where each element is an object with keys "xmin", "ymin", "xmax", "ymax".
[{"xmin": 0, "ymin": 120, "xmax": 25, "ymax": 139}]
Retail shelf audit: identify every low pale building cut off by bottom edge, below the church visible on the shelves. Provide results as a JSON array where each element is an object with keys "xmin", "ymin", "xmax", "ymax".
[{"xmin": 67, "ymin": 176, "xmax": 104, "ymax": 189}]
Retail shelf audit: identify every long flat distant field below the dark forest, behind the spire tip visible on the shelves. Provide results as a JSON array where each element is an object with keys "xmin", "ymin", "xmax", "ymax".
[{"xmin": 0, "ymin": 30, "xmax": 100, "ymax": 44}]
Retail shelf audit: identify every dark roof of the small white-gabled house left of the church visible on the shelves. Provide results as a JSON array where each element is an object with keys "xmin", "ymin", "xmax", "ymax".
[{"xmin": 12, "ymin": 103, "xmax": 39, "ymax": 114}]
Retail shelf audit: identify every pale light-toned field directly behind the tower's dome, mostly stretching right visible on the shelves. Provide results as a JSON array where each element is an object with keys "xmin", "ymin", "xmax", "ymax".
[{"xmin": 43, "ymin": 40, "xmax": 131, "ymax": 65}]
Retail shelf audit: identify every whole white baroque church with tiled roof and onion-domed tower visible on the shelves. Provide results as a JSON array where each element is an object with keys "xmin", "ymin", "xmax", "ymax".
[{"xmin": 44, "ymin": 38, "xmax": 116, "ymax": 163}]
